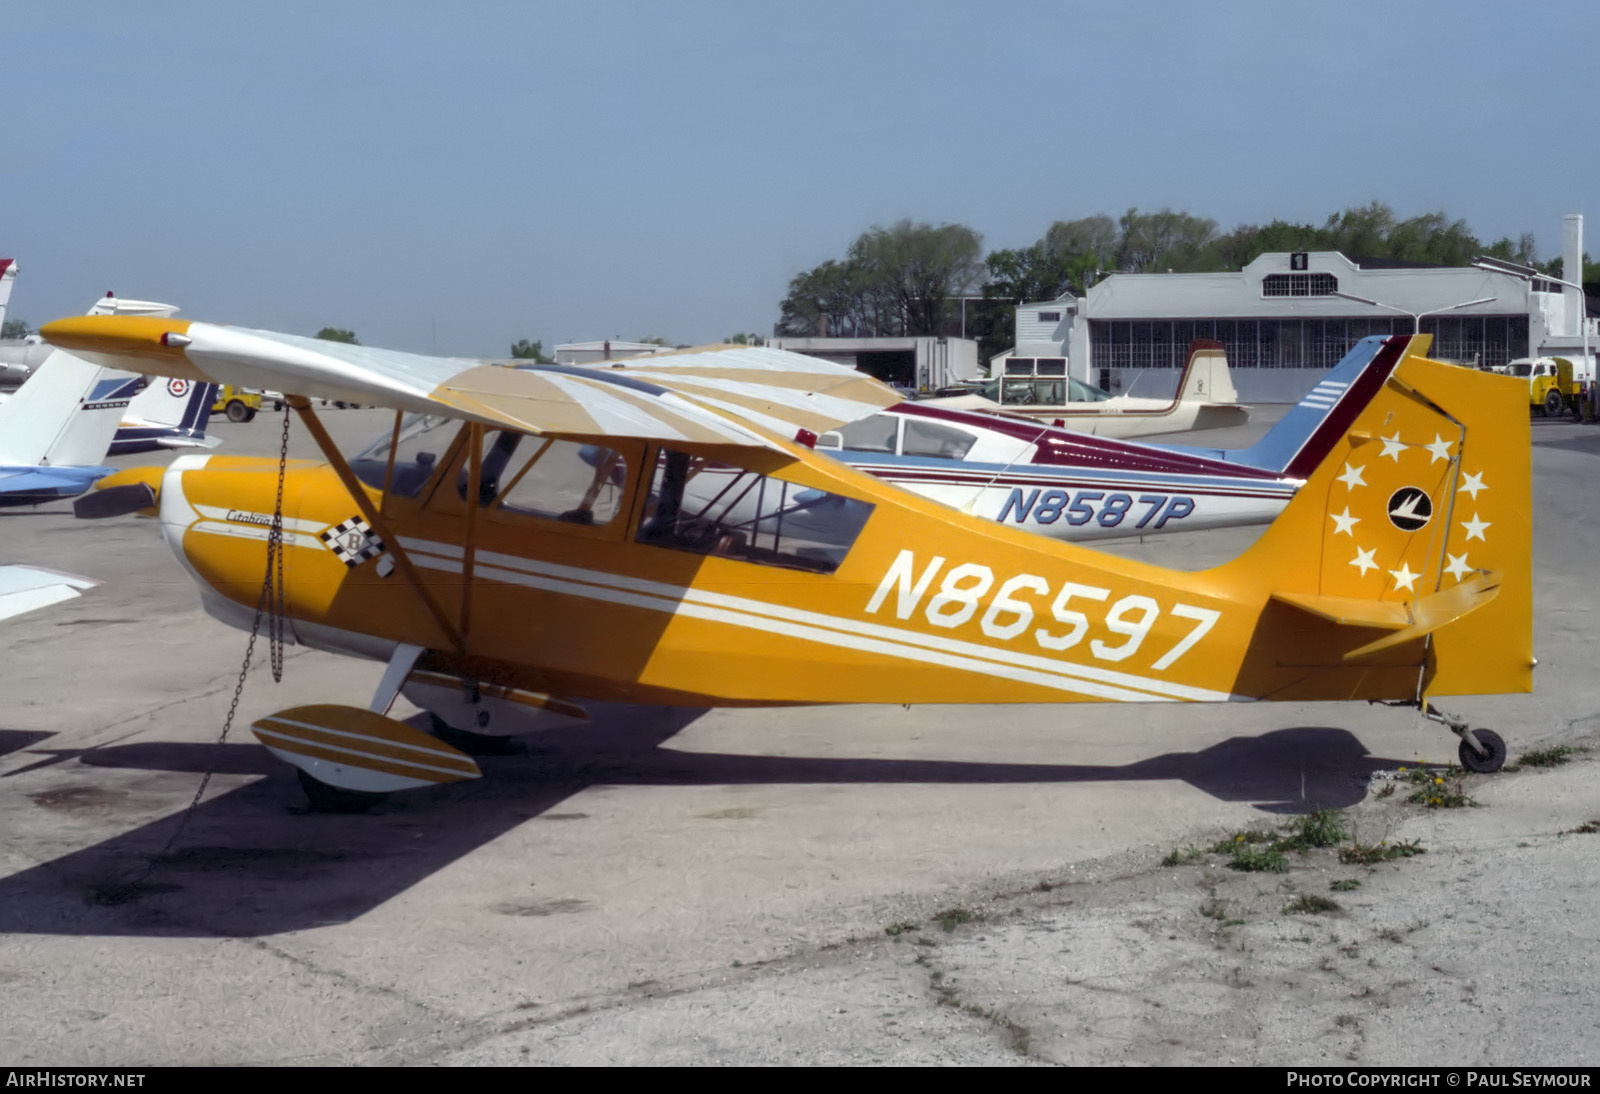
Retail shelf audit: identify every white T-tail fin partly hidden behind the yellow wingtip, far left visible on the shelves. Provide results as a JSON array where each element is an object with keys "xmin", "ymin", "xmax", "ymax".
[{"xmin": 0, "ymin": 294, "xmax": 178, "ymax": 467}]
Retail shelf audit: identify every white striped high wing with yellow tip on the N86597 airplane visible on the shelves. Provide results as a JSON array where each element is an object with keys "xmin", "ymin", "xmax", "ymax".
[{"xmin": 40, "ymin": 315, "xmax": 901, "ymax": 453}]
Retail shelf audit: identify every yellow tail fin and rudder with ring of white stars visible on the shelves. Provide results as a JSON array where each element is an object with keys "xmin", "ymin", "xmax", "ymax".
[{"xmin": 1213, "ymin": 336, "xmax": 1533, "ymax": 697}]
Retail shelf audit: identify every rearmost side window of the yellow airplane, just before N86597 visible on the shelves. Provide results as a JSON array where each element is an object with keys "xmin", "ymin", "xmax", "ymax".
[{"xmin": 638, "ymin": 449, "xmax": 872, "ymax": 574}]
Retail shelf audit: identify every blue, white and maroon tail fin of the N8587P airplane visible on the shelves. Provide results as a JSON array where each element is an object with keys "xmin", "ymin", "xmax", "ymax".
[{"xmin": 1162, "ymin": 334, "xmax": 1410, "ymax": 478}]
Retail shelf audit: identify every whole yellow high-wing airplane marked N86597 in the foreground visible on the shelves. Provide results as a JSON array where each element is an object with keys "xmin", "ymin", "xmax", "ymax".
[{"xmin": 42, "ymin": 317, "xmax": 1534, "ymax": 809}]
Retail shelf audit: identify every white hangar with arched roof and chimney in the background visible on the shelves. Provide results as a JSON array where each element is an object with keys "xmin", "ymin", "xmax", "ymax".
[{"xmin": 990, "ymin": 216, "xmax": 1600, "ymax": 403}]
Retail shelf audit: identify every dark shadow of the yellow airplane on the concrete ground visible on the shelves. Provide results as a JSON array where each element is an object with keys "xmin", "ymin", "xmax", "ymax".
[{"xmin": 0, "ymin": 709, "xmax": 1402, "ymax": 937}]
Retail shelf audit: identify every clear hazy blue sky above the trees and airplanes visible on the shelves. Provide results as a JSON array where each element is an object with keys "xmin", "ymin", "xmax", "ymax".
[{"xmin": 0, "ymin": 0, "xmax": 1600, "ymax": 355}]
